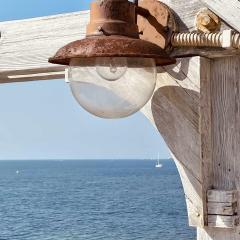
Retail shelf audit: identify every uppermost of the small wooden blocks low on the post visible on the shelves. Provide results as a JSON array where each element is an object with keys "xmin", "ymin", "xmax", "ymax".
[{"xmin": 207, "ymin": 190, "xmax": 237, "ymax": 203}]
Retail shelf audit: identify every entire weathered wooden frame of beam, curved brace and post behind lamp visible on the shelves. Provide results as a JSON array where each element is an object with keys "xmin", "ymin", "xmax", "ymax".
[{"xmin": 0, "ymin": 0, "xmax": 240, "ymax": 240}]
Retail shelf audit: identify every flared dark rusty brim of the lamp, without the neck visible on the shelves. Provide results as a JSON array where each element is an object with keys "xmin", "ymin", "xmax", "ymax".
[{"xmin": 49, "ymin": 36, "xmax": 175, "ymax": 66}]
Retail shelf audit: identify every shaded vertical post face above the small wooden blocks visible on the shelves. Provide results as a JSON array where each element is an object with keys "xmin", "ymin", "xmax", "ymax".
[{"xmin": 211, "ymin": 57, "xmax": 240, "ymax": 190}]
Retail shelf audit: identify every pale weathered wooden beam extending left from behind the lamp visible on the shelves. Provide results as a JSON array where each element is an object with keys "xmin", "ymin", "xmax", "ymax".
[{"xmin": 0, "ymin": 11, "xmax": 89, "ymax": 83}]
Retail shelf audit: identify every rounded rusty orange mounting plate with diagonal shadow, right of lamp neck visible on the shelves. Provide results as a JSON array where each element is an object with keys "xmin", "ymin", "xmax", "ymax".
[{"xmin": 137, "ymin": 0, "xmax": 177, "ymax": 49}]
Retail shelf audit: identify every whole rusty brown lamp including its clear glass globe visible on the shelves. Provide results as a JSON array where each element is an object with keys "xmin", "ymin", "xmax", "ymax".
[{"xmin": 49, "ymin": 0, "xmax": 175, "ymax": 118}]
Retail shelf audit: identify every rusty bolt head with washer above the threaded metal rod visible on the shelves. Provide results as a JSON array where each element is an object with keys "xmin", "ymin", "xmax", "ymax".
[{"xmin": 196, "ymin": 8, "xmax": 221, "ymax": 33}]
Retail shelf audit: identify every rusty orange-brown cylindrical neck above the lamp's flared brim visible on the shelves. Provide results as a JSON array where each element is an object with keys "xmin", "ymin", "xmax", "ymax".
[{"xmin": 87, "ymin": 0, "xmax": 139, "ymax": 38}]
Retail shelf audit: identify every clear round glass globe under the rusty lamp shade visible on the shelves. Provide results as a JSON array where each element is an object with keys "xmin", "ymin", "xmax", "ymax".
[{"xmin": 68, "ymin": 57, "xmax": 156, "ymax": 118}]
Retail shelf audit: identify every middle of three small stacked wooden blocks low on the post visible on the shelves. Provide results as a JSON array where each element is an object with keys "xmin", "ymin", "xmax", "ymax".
[{"xmin": 208, "ymin": 202, "xmax": 237, "ymax": 216}]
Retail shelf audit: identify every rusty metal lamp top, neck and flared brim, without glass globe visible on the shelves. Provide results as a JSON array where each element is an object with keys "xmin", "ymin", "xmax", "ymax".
[{"xmin": 49, "ymin": 0, "xmax": 176, "ymax": 66}]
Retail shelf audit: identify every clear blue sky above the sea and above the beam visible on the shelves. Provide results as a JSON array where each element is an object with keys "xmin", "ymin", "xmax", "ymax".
[{"xmin": 0, "ymin": 0, "xmax": 170, "ymax": 160}]
